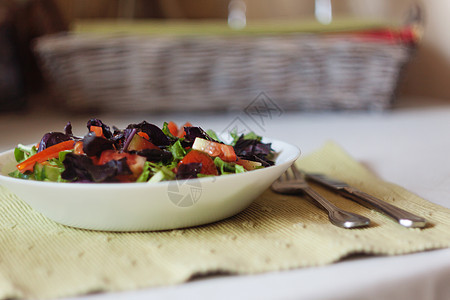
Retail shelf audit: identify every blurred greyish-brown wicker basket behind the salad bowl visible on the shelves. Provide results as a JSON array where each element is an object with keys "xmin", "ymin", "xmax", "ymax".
[{"xmin": 36, "ymin": 29, "xmax": 411, "ymax": 112}]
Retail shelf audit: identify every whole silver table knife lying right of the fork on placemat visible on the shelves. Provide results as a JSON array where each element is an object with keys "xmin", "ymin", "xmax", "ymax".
[{"xmin": 306, "ymin": 173, "xmax": 427, "ymax": 228}]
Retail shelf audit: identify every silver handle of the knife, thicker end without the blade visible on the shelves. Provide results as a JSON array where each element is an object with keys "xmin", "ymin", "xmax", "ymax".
[{"xmin": 343, "ymin": 187, "xmax": 427, "ymax": 228}]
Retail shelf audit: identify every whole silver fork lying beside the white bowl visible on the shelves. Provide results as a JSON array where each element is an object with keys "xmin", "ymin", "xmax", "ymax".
[{"xmin": 271, "ymin": 165, "xmax": 370, "ymax": 228}]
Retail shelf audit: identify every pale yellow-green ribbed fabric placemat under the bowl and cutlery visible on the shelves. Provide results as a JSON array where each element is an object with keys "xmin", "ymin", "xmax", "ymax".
[{"xmin": 0, "ymin": 143, "xmax": 450, "ymax": 299}]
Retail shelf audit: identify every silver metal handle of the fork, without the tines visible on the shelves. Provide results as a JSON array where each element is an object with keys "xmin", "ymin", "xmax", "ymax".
[{"xmin": 302, "ymin": 187, "xmax": 370, "ymax": 228}]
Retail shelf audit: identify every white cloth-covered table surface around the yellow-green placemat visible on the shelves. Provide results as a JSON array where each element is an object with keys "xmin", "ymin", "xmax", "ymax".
[{"xmin": 0, "ymin": 99, "xmax": 450, "ymax": 300}]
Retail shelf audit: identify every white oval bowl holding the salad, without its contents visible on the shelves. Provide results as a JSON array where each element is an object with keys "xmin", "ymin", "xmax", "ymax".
[{"xmin": 0, "ymin": 139, "xmax": 300, "ymax": 231}]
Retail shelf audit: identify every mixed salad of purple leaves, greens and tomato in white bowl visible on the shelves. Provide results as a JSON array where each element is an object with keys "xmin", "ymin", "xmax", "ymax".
[{"xmin": 9, "ymin": 119, "xmax": 275, "ymax": 183}]
